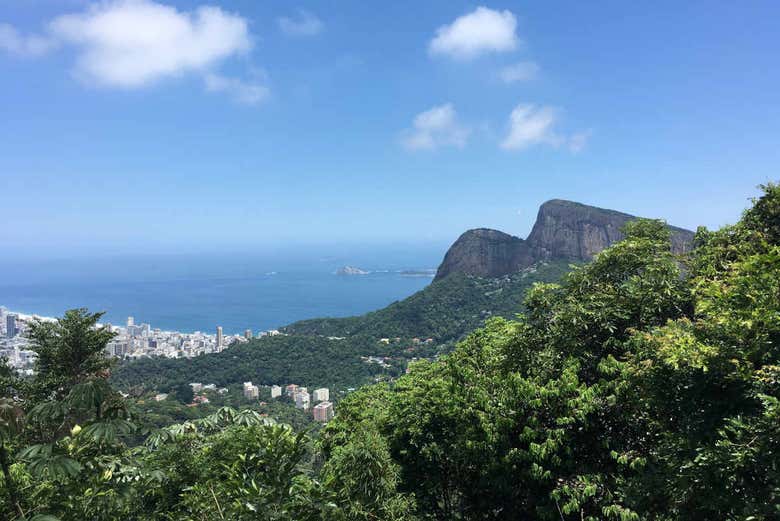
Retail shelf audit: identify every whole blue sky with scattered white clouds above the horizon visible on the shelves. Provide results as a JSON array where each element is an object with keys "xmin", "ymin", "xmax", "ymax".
[{"xmin": 0, "ymin": 0, "xmax": 780, "ymax": 255}]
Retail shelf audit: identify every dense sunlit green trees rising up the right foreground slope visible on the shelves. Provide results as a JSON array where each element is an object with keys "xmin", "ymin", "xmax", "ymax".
[{"xmin": 323, "ymin": 185, "xmax": 780, "ymax": 520}]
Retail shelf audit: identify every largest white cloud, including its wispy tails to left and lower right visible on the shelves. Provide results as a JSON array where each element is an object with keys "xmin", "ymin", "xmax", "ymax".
[{"xmin": 0, "ymin": 0, "xmax": 269, "ymax": 105}]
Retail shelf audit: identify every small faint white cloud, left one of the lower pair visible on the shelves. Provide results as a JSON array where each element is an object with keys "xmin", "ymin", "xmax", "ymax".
[{"xmin": 401, "ymin": 103, "xmax": 470, "ymax": 150}]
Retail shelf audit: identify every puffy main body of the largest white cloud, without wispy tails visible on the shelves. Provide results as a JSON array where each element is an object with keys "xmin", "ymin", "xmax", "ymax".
[{"xmin": 45, "ymin": 0, "xmax": 252, "ymax": 88}]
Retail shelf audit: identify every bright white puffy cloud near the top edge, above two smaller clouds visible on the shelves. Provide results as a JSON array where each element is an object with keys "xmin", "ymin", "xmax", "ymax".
[{"xmin": 428, "ymin": 7, "xmax": 519, "ymax": 60}]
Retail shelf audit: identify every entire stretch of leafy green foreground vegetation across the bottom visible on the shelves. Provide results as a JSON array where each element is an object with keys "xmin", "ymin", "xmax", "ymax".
[{"xmin": 0, "ymin": 185, "xmax": 780, "ymax": 521}]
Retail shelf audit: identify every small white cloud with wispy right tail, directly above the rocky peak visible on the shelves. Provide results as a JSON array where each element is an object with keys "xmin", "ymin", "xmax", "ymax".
[{"xmin": 501, "ymin": 103, "xmax": 591, "ymax": 154}]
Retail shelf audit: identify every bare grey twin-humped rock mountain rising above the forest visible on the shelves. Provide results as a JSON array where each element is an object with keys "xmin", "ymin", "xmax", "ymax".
[{"xmin": 436, "ymin": 199, "xmax": 693, "ymax": 280}]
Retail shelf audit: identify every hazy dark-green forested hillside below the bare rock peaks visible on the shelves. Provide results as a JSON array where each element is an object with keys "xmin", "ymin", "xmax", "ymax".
[{"xmin": 112, "ymin": 261, "xmax": 570, "ymax": 391}]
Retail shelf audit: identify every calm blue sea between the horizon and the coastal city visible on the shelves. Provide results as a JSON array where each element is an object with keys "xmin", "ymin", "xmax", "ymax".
[{"xmin": 0, "ymin": 247, "xmax": 443, "ymax": 333}]
